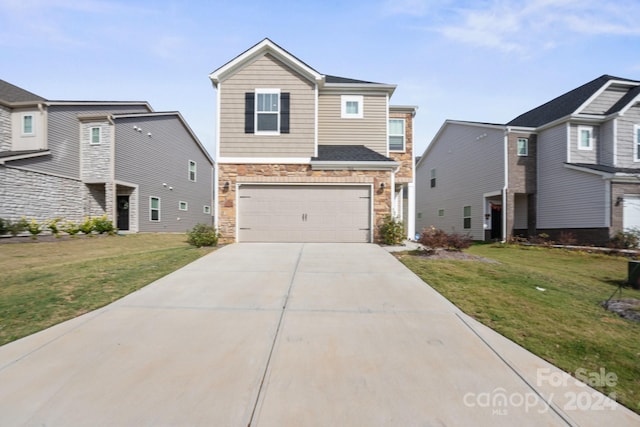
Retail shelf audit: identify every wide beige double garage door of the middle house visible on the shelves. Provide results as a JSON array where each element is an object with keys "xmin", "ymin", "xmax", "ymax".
[{"xmin": 238, "ymin": 185, "xmax": 371, "ymax": 242}]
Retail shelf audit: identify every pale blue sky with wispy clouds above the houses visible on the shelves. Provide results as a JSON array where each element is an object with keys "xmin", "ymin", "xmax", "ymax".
[{"xmin": 0, "ymin": 0, "xmax": 640, "ymax": 155}]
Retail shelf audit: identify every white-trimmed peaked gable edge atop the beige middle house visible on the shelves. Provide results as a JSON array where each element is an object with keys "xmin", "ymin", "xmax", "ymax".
[{"xmin": 209, "ymin": 38, "xmax": 324, "ymax": 87}]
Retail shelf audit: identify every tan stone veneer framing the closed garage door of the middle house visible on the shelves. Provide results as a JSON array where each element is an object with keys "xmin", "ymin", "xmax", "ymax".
[{"xmin": 218, "ymin": 164, "xmax": 391, "ymax": 243}]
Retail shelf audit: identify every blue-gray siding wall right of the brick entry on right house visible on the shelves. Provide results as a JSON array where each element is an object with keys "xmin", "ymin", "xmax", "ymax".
[{"xmin": 537, "ymin": 124, "xmax": 607, "ymax": 229}]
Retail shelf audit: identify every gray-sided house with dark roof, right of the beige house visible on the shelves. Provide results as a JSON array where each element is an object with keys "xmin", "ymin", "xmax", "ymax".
[{"xmin": 416, "ymin": 75, "xmax": 640, "ymax": 244}]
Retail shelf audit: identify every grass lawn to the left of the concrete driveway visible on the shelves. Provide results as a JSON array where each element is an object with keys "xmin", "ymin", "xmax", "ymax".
[{"xmin": 0, "ymin": 234, "xmax": 213, "ymax": 345}]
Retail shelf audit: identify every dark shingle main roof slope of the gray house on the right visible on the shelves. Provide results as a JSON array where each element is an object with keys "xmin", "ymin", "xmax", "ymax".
[{"xmin": 507, "ymin": 74, "xmax": 637, "ymax": 127}]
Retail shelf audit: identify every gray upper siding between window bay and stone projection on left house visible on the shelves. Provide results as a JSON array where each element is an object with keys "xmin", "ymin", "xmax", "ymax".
[{"xmin": 11, "ymin": 105, "xmax": 148, "ymax": 179}]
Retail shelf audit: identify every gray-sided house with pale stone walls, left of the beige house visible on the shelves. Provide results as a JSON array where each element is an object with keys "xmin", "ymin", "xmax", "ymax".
[{"xmin": 0, "ymin": 80, "xmax": 213, "ymax": 232}]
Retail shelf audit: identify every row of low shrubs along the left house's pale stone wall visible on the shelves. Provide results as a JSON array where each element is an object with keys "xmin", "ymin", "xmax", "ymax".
[{"xmin": 0, "ymin": 215, "xmax": 116, "ymax": 239}]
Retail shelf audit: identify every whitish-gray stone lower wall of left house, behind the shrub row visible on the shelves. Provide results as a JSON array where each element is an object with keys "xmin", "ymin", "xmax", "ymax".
[{"xmin": 0, "ymin": 166, "xmax": 86, "ymax": 222}]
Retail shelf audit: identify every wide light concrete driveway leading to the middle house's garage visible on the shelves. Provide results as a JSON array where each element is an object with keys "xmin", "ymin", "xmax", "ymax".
[{"xmin": 0, "ymin": 244, "xmax": 640, "ymax": 427}]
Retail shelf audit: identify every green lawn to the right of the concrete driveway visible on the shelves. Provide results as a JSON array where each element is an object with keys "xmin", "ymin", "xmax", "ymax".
[{"xmin": 399, "ymin": 244, "xmax": 640, "ymax": 413}]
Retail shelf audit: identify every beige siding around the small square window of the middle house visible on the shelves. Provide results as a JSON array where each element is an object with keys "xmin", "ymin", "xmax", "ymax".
[{"xmin": 318, "ymin": 93, "xmax": 387, "ymax": 156}]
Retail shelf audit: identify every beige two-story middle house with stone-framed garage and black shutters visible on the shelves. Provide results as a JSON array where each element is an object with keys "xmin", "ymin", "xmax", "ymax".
[{"xmin": 209, "ymin": 39, "xmax": 416, "ymax": 242}]
